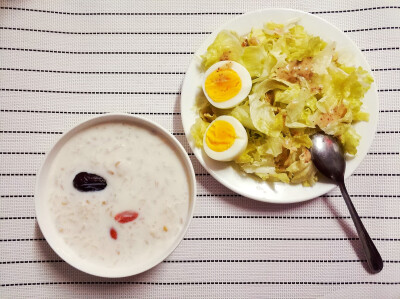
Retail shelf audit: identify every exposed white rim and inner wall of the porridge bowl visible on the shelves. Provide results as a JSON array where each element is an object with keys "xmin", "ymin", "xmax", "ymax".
[{"xmin": 35, "ymin": 114, "xmax": 196, "ymax": 277}]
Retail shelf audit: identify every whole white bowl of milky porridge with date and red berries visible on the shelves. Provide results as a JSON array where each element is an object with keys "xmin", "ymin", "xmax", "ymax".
[{"xmin": 35, "ymin": 114, "xmax": 196, "ymax": 277}]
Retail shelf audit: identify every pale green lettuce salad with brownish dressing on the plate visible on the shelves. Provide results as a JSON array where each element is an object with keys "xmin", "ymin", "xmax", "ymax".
[{"xmin": 191, "ymin": 23, "xmax": 373, "ymax": 186}]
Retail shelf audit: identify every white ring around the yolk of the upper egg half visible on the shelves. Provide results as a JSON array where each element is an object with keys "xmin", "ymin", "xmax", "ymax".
[{"xmin": 202, "ymin": 60, "xmax": 252, "ymax": 109}]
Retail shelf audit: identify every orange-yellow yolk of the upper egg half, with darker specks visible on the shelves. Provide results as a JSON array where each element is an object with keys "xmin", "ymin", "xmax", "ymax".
[{"xmin": 204, "ymin": 68, "xmax": 242, "ymax": 103}]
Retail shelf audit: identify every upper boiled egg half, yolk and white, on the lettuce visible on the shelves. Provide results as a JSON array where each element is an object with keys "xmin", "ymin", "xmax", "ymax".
[{"xmin": 203, "ymin": 61, "xmax": 251, "ymax": 109}]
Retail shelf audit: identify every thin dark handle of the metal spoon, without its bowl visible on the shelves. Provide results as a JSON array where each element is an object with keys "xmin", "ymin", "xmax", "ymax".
[{"xmin": 338, "ymin": 181, "xmax": 383, "ymax": 273}]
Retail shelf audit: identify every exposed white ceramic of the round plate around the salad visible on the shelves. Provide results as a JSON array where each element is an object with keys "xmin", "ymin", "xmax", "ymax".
[{"xmin": 181, "ymin": 9, "xmax": 378, "ymax": 203}]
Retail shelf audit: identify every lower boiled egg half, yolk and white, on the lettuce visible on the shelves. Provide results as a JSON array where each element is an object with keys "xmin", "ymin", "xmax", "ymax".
[{"xmin": 203, "ymin": 115, "xmax": 247, "ymax": 161}]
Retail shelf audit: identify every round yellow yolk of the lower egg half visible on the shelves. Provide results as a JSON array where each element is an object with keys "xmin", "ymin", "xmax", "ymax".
[{"xmin": 206, "ymin": 120, "xmax": 236, "ymax": 152}]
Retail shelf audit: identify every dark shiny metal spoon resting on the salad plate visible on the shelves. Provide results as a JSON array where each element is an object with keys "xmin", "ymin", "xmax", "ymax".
[{"xmin": 311, "ymin": 133, "xmax": 383, "ymax": 273}]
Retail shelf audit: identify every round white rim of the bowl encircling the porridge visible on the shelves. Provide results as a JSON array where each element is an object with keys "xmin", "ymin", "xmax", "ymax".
[{"xmin": 34, "ymin": 113, "xmax": 196, "ymax": 278}]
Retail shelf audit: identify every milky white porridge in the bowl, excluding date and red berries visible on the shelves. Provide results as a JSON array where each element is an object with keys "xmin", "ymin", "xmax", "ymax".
[{"xmin": 46, "ymin": 123, "xmax": 189, "ymax": 267}]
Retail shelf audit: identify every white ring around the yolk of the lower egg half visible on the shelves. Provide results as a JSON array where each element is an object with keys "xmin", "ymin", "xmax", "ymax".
[{"xmin": 203, "ymin": 115, "xmax": 247, "ymax": 161}]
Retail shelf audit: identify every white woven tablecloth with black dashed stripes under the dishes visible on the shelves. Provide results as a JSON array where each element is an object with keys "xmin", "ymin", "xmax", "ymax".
[{"xmin": 0, "ymin": 0, "xmax": 400, "ymax": 298}]
